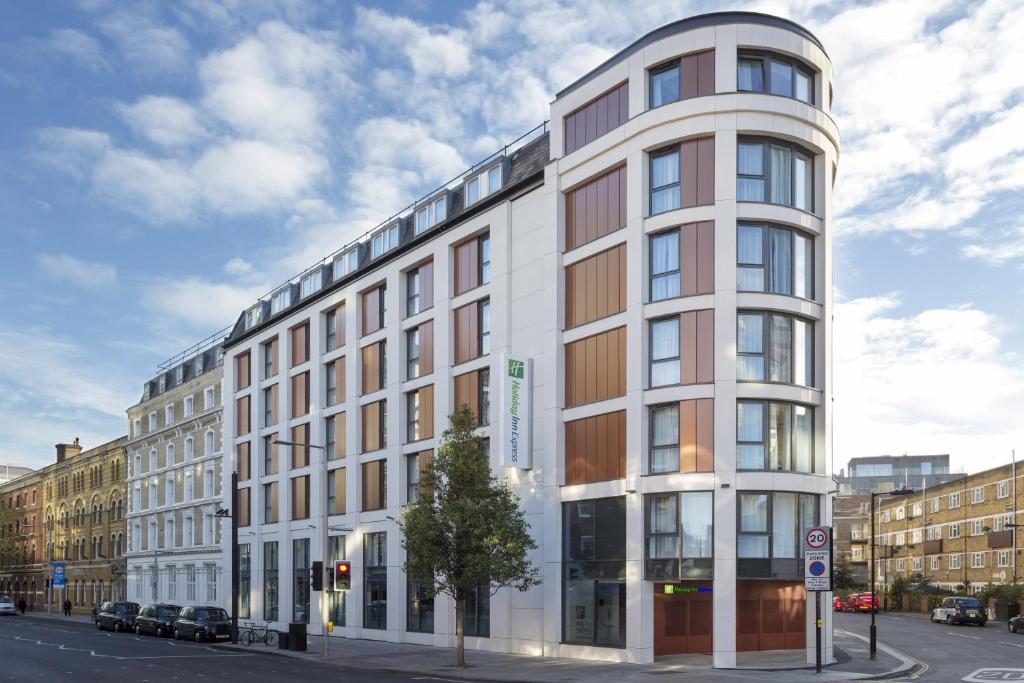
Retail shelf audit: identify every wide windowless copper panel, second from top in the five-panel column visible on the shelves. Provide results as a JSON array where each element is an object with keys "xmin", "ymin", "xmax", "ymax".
[{"xmin": 565, "ymin": 166, "xmax": 626, "ymax": 251}]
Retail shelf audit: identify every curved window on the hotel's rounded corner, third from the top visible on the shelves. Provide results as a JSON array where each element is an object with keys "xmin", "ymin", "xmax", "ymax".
[{"xmin": 736, "ymin": 223, "xmax": 814, "ymax": 299}]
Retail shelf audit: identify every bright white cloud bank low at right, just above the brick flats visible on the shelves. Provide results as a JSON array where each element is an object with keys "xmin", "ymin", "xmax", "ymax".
[{"xmin": 834, "ymin": 295, "xmax": 1024, "ymax": 471}]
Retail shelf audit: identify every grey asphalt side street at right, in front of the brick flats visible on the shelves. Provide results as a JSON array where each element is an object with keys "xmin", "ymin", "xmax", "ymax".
[{"xmin": 835, "ymin": 613, "xmax": 1024, "ymax": 681}]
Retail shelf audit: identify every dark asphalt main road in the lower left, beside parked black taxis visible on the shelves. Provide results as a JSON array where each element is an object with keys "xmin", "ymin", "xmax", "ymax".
[{"xmin": 0, "ymin": 616, "xmax": 471, "ymax": 683}]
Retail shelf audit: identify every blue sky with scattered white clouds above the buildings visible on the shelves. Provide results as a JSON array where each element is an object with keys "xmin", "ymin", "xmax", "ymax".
[{"xmin": 0, "ymin": 0, "xmax": 1024, "ymax": 470}]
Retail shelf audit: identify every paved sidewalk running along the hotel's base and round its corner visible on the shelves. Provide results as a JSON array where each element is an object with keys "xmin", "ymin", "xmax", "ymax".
[{"xmin": 215, "ymin": 630, "xmax": 916, "ymax": 683}]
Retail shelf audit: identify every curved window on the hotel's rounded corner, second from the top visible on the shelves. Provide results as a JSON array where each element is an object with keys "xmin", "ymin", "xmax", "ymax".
[{"xmin": 741, "ymin": 138, "xmax": 814, "ymax": 213}]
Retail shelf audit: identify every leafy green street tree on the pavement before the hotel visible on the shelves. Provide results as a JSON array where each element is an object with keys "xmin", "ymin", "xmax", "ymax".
[{"xmin": 399, "ymin": 405, "xmax": 540, "ymax": 667}]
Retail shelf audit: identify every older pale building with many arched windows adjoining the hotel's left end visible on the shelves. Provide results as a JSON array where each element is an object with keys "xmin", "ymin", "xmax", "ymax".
[{"xmin": 125, "ymin": 339, "xmax": 230, "ymax": 605}]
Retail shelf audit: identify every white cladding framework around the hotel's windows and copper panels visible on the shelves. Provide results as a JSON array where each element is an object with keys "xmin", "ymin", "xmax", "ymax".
[{"xmin": 222, "ymin": 14, "xmax": 839, "ymax": 668}]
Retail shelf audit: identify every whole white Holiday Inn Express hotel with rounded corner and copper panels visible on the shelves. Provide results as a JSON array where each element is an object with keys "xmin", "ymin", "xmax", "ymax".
[{"xmin": 223, "ymin": 12, "xmax": 839, "ymax": 668}]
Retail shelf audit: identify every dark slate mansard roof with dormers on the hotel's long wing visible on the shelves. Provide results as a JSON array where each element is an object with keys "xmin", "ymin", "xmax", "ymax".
[{"xmin": 224, "ymin": 122, "xmax": 550, "ymax": 348}]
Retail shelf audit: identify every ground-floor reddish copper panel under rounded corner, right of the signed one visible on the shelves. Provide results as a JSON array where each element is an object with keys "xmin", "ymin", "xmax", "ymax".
[{"xmin": 736, "ymin": 581, "xmax": 806, "ymax": 652}]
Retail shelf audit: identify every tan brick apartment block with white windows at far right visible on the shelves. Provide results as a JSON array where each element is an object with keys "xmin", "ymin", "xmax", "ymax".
[{"xmin": 876, "ymin": 463, "xmax": 1024, "ymax": 593}]
